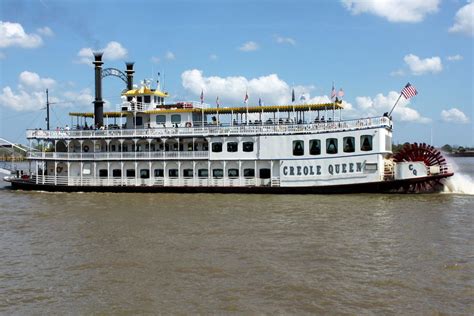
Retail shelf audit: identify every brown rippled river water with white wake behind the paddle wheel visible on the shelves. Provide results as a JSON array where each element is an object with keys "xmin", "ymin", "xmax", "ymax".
[{"xmin": 0, "ymin": 158, "xmax": 474, "ymax": 315}]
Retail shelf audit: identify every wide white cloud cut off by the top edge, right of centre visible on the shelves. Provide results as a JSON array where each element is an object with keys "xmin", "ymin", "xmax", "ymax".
[{"xmin": 341, "ymin": 0, "xmax": 440, "ymax": 23}]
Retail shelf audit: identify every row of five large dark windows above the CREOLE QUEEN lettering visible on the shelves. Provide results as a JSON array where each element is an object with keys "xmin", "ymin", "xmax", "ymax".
[{"xmin": 293, "ymin": 135, "xmax": 372, "ymax": 156}]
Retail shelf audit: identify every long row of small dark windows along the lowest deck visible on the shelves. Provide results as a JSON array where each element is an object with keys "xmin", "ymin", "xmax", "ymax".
[{"xmin": 99, "ymin": 168, "xmax": 270, "ymax": 179}]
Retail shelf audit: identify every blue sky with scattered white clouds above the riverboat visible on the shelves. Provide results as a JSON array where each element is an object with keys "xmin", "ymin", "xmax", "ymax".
[{"xmin": 0, "ymin": 0, "xmax": 474, "ymax": 147}]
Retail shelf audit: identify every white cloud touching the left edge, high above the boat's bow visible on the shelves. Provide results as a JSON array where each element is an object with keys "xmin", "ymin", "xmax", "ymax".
[{"xmin": 0, "ymin": 21, "xmax": 43, "ymax": 48}]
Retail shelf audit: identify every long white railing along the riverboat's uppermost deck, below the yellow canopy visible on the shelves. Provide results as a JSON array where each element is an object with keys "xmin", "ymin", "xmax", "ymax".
[{"xmin": 26, "ymin": 116, "xmax": 391, "ymax": 139}]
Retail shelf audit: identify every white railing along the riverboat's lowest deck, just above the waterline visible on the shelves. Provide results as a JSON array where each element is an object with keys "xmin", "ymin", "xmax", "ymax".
[{"xmin": 30, "ymin": 175, "xmax": 274, "ymax": 187}]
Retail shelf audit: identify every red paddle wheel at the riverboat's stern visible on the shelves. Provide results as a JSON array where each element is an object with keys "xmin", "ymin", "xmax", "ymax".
[{"xmin": 393, "ymin": 143, "xmax": 448, "ymax": 193}]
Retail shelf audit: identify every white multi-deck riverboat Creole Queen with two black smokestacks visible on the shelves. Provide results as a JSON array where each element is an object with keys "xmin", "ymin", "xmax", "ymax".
[{"xmin": 8, "ymin": 53, "xmax": 453, "ymax": 193}]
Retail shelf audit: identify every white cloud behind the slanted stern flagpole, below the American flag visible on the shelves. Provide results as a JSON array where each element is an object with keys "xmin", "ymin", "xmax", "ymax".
[{"xmin": 356, "ymin": 91, "xmax": 431, "ymax": 123}]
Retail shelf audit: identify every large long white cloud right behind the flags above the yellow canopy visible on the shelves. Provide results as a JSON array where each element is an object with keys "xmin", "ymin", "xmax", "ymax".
[{"xmin": 181, "ymin": 69, "xmax": 330, "ymax": 106}]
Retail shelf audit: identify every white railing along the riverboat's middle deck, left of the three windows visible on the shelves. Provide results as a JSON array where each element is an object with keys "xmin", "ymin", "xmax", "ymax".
[{"xmin": 28, "ymin": 151, "xmax": 209, "ymax": 160}]
